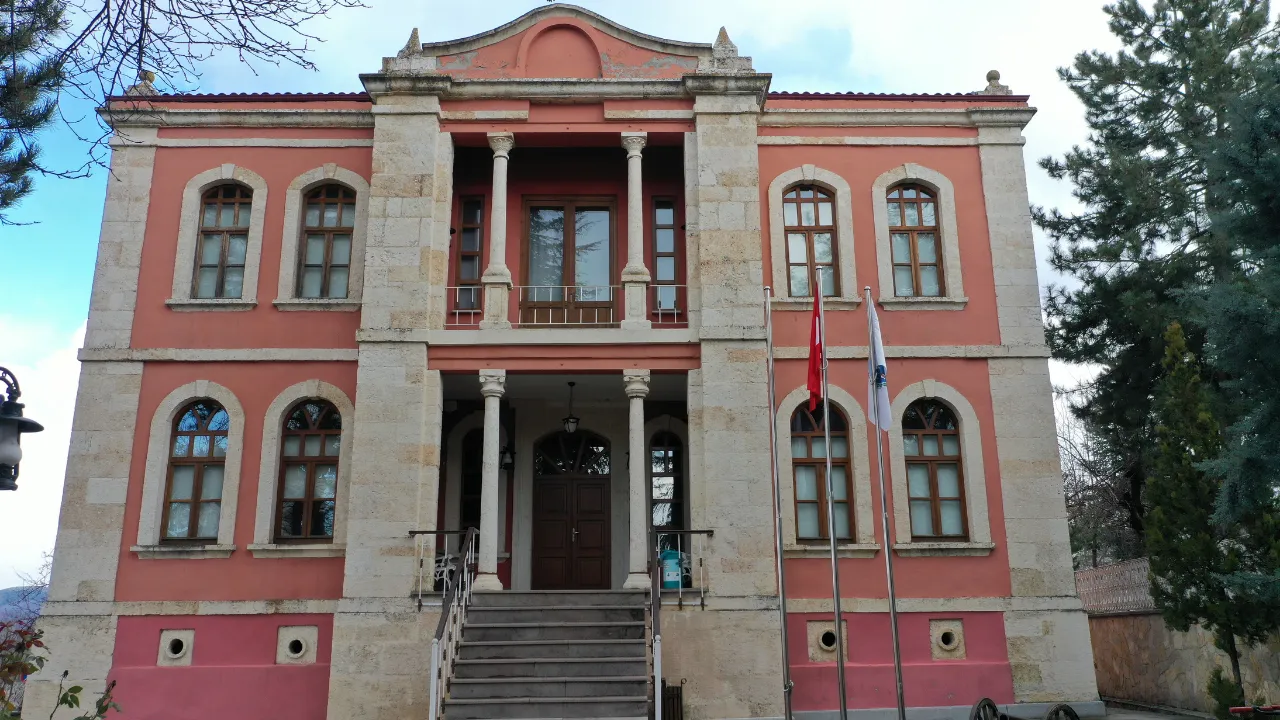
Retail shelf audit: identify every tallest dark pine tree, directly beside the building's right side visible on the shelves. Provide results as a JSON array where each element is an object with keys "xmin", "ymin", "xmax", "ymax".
[{"xmin": 1033, "ymin": 0, "xmax": 1276, "ymax": 537}]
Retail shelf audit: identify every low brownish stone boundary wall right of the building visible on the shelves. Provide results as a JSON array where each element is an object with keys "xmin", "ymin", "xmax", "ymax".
[{"xmin": 1089, "ymin": 614, "xmax": 1280, "ymax": 712}]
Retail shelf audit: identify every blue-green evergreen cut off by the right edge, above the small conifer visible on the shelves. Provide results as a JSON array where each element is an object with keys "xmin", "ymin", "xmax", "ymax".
[{"xmin": 1204, "ymin": 59, "xmax": 1280, "ymax": 527}]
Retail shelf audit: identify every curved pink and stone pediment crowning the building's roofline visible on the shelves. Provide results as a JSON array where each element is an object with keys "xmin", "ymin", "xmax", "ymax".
[{"xmin": 385, "ymin": 4, "xmax": 750, "ymax": 81}]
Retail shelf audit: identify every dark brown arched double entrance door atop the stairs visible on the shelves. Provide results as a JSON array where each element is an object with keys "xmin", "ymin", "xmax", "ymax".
[{"xmin": 531, "ymin": 430, "xmax": 611, "ymax": 589}]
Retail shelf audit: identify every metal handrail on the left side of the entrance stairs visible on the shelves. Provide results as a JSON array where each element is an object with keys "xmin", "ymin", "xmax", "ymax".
[{"xmin": 410, "ymin": 528, "xmax": 480, "ymax": 720}]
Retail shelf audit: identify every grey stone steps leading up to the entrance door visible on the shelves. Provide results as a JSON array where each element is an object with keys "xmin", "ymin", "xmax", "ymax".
[{"xmin": 444, "ymin": 591, "xmax": 649, "ymax": 720}]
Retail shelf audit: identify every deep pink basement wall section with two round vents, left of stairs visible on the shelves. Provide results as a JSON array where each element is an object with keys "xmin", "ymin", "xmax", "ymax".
[{"xmin": 109, "ymin": 615, "xmax": 333, "ymax": 720}]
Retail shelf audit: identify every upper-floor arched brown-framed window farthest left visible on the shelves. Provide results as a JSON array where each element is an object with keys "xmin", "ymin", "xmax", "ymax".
[{"xmin": 191, "ymin": 183, "xmax": 253, "ymax": 299}]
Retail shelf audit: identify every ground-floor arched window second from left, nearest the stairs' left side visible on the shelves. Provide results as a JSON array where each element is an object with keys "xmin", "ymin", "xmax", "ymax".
[{"xmin": 275, "ymin": 398, "xmax": 342, "ymax": 542}]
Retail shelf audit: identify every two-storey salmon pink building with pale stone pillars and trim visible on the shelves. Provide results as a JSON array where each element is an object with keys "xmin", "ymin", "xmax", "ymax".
[{"xmin": 35, "ymin": 4, "xmax": 1101, "ymax": 720}]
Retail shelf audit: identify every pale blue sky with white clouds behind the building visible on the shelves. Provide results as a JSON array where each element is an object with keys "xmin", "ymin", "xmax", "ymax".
[{"xmin": 0, "ymin": 0, "xmax": 1117, "ymax": 588}]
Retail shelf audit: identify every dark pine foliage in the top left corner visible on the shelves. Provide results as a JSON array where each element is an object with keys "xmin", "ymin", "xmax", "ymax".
[{"xmin": 0, "ymin": 0, "xmax": 64, "ymax": 224}]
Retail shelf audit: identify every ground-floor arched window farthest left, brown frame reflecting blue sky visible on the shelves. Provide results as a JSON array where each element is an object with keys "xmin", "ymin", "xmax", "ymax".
[{"xmin": 163, "ymin": 398, "xmax": 230, "ymax": 541}]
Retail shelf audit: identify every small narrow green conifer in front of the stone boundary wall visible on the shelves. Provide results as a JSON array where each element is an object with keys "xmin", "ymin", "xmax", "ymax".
[{"xmin": 1147, "ymin": 323, "xmax": 1280, "ymax": 696}]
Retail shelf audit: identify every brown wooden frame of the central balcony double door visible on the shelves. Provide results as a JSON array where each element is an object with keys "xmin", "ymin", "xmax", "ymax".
[{"xmin": 517, "ymin": 195, "xmax": 622, "ymax": 327}]
